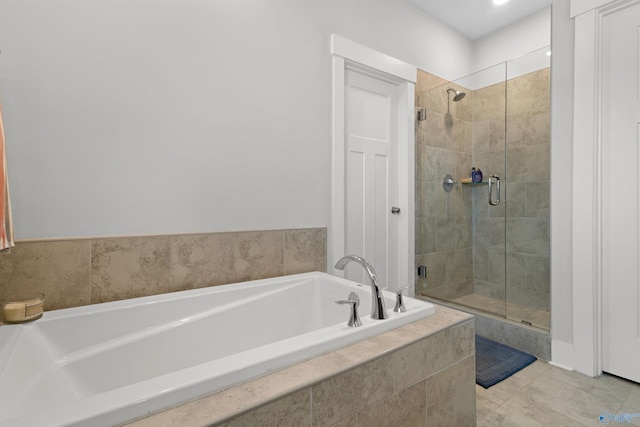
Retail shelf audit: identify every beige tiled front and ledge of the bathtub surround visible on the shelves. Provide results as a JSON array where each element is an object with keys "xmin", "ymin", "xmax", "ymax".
[{"xmin": 127, "ymin": 306, "xmax": 476, "ymax": 427}]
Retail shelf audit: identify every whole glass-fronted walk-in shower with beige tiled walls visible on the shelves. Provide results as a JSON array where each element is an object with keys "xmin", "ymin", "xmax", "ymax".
[{"xmin": 416, "ymin": 48, "xmax": 550, "ymax": 330}]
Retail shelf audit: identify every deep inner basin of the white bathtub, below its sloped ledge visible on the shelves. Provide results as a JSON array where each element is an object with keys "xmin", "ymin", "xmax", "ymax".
[{"xmin": 55, "ymin": 280, "xmax": 376, "ymax": 396}]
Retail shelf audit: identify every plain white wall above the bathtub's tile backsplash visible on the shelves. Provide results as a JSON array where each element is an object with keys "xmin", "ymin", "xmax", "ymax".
[{"xmin": 0, "ymin": 0, "xmax": 472, "ymax": 239}]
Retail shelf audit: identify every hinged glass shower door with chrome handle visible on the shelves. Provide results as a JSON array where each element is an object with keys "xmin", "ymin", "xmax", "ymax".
[{"xmin": 416, "ymin": 64, "xmax": 506, "ymax": 317}]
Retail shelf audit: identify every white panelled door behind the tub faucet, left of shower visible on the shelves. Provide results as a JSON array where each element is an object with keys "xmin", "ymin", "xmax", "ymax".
[{"xmin": 344, "ymin": 70, "xmax": 402, "ymax": 288}]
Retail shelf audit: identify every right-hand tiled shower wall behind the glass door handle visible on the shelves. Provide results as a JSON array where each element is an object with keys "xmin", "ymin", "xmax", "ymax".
[{"xmin": 473, "ymin": 68, "xmax": 550, "ymax": 314}]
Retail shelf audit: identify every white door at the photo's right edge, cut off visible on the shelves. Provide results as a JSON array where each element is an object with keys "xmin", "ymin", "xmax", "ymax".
[{"xmin": 604, "ymin": 5, "xmax": 640, "ymax": 382}]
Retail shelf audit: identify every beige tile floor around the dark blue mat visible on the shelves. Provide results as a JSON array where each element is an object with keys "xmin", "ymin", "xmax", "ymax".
[{"xmin": 476, "ymin": 360, "xmax": 640, "ymax": 427}]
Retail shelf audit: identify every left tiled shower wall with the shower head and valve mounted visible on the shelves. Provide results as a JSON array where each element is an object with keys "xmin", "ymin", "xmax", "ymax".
[{"xmin": 415, "ymin": 71, "xmax": 473, "ymax": 299}]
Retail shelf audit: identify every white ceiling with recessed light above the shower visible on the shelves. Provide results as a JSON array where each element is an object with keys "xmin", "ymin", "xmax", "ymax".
[{"xmin": 408, "ymin": 0, "xmax": 552, "ymax": 40}]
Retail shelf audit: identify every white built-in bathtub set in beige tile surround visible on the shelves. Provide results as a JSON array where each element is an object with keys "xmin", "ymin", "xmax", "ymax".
[{"xmin": 0, "ymin": 273, "xmax": 435, "ymax": 427}]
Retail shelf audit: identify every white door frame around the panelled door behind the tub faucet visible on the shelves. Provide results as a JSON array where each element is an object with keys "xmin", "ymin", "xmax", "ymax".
[{"xmin": 327, "ymin": 34, "xmax": 418, "ymax": 295}]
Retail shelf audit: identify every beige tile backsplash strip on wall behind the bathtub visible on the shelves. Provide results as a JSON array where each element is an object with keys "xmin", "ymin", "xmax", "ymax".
[{"xmin": 0, "ymin": 228, "xmax": 327, "ymax": 320}]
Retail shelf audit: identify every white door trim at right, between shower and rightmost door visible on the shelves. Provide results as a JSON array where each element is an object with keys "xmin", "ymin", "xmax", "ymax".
[{"xmin": 568, "ymin": 0, "xmax": 640, "ymax": 376}]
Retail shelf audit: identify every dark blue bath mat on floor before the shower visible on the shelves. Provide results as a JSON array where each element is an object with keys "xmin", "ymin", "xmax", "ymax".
[{"xmin": 476, "ymin": 335, "xmax": 537, "ymax": 388}]
